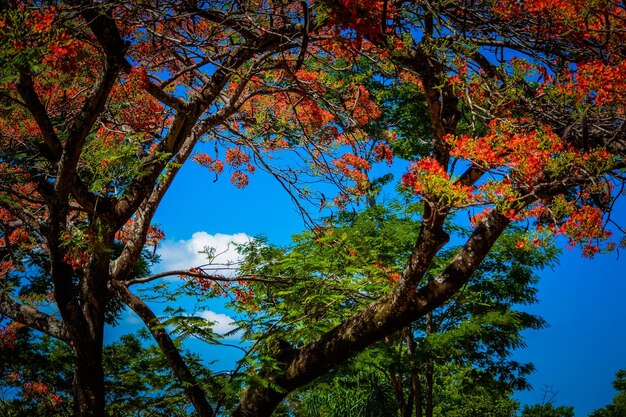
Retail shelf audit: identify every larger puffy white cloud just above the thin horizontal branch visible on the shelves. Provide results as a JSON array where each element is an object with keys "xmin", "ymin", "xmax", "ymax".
[{"xmin": 158, "ymin": 232, "xmax": 252, "ymax": 276}]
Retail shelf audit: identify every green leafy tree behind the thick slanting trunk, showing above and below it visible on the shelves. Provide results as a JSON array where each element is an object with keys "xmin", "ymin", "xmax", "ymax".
[{"xmin": 235, "ymin": 202, "xmax": 558, "ymax": 417}]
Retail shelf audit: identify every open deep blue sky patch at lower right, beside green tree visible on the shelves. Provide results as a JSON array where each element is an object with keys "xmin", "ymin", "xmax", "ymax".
[{"xmin": 516, "ymin": 247, "xmax": 626, "ymax": 417}]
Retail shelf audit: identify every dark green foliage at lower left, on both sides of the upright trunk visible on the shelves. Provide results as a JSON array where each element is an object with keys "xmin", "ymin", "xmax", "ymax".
[{"xmin": 0, "ymin": 329, "xmax": 214, "ymax": 417}]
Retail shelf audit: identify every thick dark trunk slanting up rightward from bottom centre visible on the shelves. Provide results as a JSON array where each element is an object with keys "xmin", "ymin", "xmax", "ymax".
[{"xmin": 232, "ymin": 211, "xmax": 510, "ymax": 417}]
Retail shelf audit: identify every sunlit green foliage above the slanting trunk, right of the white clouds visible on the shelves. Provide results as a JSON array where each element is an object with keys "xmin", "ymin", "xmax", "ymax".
[{"xmin": 235, "ymin": 204, "xmax": 417, "ymax": 345}]
